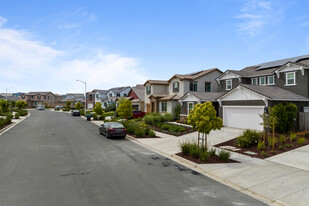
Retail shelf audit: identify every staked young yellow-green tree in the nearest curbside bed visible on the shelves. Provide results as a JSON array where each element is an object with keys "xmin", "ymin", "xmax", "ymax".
[{"xmin": 188, "ymin": 102, "xmax": 223, "ymax": 148}]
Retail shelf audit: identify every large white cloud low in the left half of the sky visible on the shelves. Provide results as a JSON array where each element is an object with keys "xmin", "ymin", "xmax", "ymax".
[{"xmin": 0, "ymin": 17, "xmax": 147, "ymax": 93}]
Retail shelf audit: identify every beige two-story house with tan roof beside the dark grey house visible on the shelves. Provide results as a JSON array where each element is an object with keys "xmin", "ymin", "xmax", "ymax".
[{"xmin": 144, "ymin": 68, "xmax": 222, "ymax": 116}]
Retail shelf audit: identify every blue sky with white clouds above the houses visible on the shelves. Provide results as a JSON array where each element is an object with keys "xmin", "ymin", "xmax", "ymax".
[{"xmin": 0, "ymin": 0, "xmax": 309, "ymax": 94}]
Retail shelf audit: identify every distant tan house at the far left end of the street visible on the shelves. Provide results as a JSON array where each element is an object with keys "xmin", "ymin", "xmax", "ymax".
[{"xmin": 19, "ymin": 92, "xmax": 58, "ymax": 107}]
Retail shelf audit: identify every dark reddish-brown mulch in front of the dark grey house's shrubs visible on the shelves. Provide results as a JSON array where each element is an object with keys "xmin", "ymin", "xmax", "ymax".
[{"xmin": 215, "ymin": 137, "xmax": 309, "ymax": 159}]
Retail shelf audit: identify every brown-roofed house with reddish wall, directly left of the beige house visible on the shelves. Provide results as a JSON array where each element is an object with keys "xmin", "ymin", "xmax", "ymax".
[{"xmin": 127, "ymin": 84, "xmax": 145, "ymax": 111}]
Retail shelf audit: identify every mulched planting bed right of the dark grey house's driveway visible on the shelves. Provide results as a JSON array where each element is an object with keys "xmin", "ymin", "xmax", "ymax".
[{"xmin": 215, "ymin": 133, "xmax": 309, "ymax": 159}]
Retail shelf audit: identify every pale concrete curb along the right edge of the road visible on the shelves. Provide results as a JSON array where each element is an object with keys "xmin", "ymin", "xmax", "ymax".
[{"xmin": 86, "ymin": 118, "xmax": 283, "ymax": 206}]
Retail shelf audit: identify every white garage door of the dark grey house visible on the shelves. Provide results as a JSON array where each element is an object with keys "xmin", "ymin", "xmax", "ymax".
[{"xmin": 223, "ymin": 106, "xmax": 264, "ymax": 130}]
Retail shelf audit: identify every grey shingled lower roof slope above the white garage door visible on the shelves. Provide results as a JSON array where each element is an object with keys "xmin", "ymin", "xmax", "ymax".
[{"xmin": 240, "ymin": 84, "xmax": 309, "ymax": 101}]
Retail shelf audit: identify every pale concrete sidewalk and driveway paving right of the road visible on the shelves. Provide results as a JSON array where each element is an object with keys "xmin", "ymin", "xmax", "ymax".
[{"xmin": 59, "ymin": 112, "xmax": 309, "ymax": 206}]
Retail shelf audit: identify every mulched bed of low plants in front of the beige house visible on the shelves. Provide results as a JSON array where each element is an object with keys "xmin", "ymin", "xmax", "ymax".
[{"xmin": 149, "ymin": 123, "xmax": 196, "ymax": 136}]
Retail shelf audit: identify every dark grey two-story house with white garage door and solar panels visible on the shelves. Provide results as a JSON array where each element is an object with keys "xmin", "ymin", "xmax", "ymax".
[{"xmin": 217, "ymin": 55, "xmax": 309, "ymax": 130}]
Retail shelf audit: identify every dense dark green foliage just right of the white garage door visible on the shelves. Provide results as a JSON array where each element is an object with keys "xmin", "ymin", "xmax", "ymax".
[{"xmin": 271, "ymin": 103, "xmax": 297, "ymax": 133}]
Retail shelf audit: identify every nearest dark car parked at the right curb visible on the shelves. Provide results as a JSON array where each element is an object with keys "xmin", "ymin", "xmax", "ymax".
[{"xmin": 99, "ymin": 122, "xmax": 127, "ymax": 138}]
